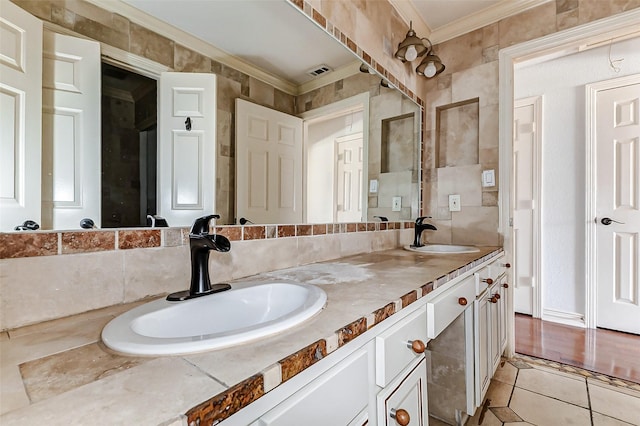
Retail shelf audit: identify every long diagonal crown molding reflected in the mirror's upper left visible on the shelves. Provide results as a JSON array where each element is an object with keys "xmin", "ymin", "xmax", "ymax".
[{"xmin": 87, "ymin": 0, "xmax": 298, "ymax": 95}]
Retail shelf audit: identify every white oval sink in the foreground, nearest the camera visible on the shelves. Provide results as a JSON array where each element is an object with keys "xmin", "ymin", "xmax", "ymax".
[{"xmin": 102, "ymin": 282, "xmax": 327, "ymax": 355}]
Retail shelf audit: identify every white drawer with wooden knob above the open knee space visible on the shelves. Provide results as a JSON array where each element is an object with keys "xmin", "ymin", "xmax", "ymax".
[{"xmin": 427, "ymin": 276, "xmax": 476, "ymax": 339}]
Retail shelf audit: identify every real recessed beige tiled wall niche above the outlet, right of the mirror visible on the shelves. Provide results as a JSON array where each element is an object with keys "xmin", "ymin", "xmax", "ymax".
[{"xmin": 436, "ymin": 98, "xmax": 480, "ymax": 167}]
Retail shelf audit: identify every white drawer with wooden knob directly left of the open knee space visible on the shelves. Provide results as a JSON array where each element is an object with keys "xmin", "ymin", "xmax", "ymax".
[{"xmin": 376, "ymin": 307, "xmax": 427, "ymax": 387}]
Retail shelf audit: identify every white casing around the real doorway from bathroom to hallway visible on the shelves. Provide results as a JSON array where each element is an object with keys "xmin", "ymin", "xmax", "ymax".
[{"xmin": 498, "ymin": 9, "xmax": 640, "ymax": 356}]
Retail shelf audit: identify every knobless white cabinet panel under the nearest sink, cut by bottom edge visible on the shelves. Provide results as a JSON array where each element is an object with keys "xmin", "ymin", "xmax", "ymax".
[{"xmin": 253, "ymin": 349, "xmax": 369, "ymax": 426}]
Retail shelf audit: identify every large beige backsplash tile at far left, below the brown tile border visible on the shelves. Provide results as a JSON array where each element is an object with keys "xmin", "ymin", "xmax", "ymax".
[{"xmin": 0, "ymin": 251, "xmax": 124, "ymax": 330}]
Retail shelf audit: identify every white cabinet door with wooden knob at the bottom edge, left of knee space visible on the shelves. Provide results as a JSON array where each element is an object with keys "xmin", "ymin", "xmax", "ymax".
[{"xmin": 377, "ymin": 357, "xmax": 429, "ymax": 426}]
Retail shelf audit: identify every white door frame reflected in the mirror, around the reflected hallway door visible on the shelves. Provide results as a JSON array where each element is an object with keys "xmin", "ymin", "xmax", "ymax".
[{"xmin": 298, "ymin": 92, "xmax": 369, "ymax": 223}]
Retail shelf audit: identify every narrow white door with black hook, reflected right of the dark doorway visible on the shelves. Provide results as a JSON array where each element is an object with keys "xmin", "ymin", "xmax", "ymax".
[{"xmin": 158, "ymin": 72, "xmax": 216, "ymax": 226}]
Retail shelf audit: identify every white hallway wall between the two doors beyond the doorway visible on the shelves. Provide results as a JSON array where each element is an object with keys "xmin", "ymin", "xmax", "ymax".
[{"xmin": 514, "ymin": 38, "xmax": 640, "ymax": 314}]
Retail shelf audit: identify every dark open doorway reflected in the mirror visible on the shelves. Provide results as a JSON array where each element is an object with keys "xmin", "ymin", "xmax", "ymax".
[{"xmin": 100, "ymin": 63, "xmax": 158, "ymax": 228}]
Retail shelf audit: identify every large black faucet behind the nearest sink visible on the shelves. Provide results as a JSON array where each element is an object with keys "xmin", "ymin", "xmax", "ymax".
[{"xmin": 167, "ymin": 214, "xmax": 231, "ymax": 301}]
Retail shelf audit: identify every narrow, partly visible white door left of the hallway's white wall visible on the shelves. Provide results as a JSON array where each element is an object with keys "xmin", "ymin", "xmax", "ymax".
[{"xmin": 512, "ymin": 98, "xmax": 541, "ymax": 317}]
